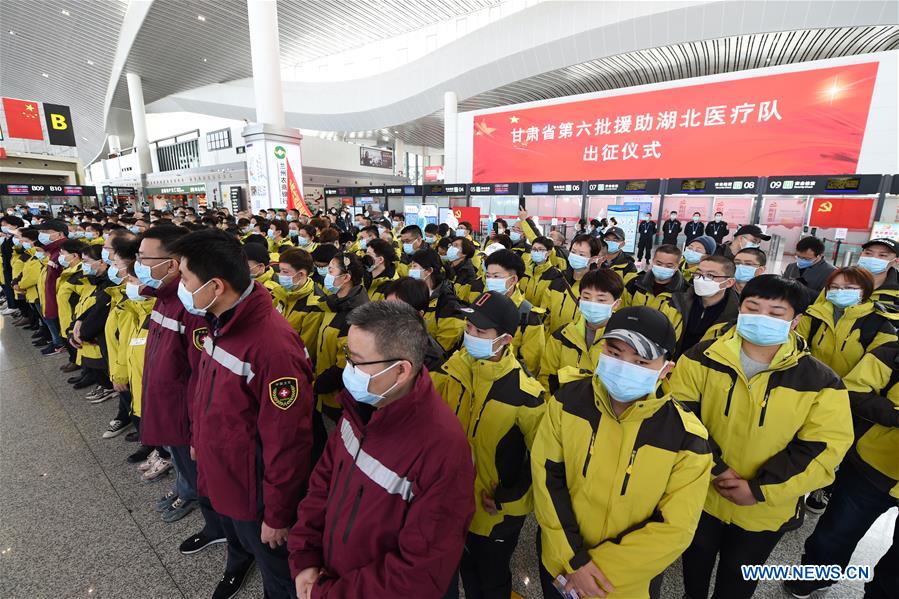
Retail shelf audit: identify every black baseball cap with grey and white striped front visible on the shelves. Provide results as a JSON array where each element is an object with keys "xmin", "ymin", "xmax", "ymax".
[{"xmin": 602, "ymin": 306, "xmax": 677, "ymax": 360}]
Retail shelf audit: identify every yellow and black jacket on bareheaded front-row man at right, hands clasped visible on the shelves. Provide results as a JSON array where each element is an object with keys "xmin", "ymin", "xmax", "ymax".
[{"xmin": 670, "ymin": 329, "xmax": 852, "ymax": 531}]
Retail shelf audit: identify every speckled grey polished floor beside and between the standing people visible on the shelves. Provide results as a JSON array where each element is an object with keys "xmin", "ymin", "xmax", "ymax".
[{"xmin": 0, "ymin": 318, "xmax": 897, "ymax": 599}]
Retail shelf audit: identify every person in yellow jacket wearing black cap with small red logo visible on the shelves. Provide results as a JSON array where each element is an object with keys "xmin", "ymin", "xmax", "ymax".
[{"xmin": 431, "ymin": 292, "xmax": 545, "ymax": 597}]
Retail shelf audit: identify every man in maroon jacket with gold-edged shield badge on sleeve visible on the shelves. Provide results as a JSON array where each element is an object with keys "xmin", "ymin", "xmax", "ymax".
[{"xmin": 172, "ymin": 229, "xmax": 313, "ymax": 599}]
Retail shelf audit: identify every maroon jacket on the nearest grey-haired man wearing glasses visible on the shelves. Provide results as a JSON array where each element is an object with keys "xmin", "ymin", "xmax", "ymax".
[{"xmin": 287, "ymin": 369, "xmax": 474, "ymax": 599}]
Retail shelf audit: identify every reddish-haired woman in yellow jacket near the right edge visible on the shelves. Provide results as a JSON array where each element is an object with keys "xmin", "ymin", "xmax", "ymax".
[{"xmin": 796, "ymin": 266, "xmax": 896, "ymax": 377}]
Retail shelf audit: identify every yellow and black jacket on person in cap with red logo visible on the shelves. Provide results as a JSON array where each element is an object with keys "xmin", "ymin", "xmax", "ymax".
[{"xmin": 431, "ymin": 348, "xmax": 546, "ymax": 538}]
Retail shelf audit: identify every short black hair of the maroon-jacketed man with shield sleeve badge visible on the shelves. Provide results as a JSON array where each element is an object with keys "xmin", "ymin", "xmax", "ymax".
[{"xmin": 171, "ymin": 229, "xmax": 251, "ymax": 293}]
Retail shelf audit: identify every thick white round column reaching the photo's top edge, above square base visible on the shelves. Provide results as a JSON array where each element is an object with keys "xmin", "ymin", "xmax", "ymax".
[{"xmin": 247, "ymin": 0, "xmax": 286, "ymax": 127}]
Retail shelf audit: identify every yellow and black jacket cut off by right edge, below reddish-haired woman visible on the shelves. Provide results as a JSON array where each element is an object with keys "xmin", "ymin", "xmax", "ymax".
[{"xmin": 843, "ymin": 342, "xmax": 899, "ymax": 499}]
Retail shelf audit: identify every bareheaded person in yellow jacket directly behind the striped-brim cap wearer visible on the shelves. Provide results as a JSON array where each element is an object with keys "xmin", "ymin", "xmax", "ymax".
[{"xmin": 538, "ymin": 268, "xmax": 624, "ymax": 393}]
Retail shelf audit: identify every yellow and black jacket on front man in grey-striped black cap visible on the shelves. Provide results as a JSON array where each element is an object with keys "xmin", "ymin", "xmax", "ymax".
[{"xmin": 531, "ymin": 369, "xmax": 712, "ymax": 599}]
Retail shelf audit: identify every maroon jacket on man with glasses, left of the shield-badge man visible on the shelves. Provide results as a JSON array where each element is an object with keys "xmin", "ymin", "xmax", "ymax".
[{"xmin": 140, "ymin": 277, "xmax": 203, "ymax": 446}]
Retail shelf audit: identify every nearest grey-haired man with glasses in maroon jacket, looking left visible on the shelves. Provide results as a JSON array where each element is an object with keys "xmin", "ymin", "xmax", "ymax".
[{"xmin": 288, "ymin": 301, "xmax": 474, "ymax": 599}]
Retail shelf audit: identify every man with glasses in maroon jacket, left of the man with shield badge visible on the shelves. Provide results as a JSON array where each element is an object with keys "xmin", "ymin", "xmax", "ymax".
[{"xmin": 134, "ymin": 224, "xmax": 225, "ymax": 554}]
